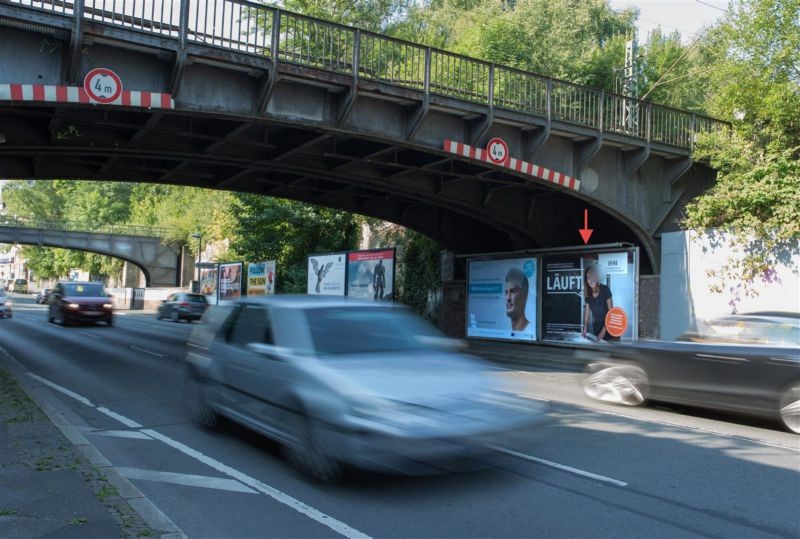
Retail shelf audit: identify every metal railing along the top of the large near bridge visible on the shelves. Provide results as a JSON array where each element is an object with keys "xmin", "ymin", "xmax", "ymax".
[{"xmin": 8, "ymin": 0, "xmax": 728, "ymax": 149}]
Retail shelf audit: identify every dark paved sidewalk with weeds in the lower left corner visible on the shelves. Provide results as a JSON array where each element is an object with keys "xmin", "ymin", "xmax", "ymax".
[{"xmin": 0, "ymin": 364, "xmax": 174, "ymax": 539}]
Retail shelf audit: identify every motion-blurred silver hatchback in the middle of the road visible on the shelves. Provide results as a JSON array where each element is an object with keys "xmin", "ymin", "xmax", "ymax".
[{"xmin": 187, "ymin": 296, "xmax": 545, "ymax": 480}]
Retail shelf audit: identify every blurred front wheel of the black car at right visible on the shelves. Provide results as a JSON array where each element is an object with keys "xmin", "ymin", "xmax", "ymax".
[{"xmin": 583, "ymin": 364, "xmax": 649, "ymax": 406}]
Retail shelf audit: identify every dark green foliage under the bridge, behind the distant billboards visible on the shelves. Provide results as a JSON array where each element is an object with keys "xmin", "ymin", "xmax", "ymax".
[{"xmin": 230, "ymin": 194, "xmax": 359, "ymax": 293}]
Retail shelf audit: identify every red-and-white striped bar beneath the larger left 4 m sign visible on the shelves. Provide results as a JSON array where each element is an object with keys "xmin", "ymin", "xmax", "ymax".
[{"xmin": 0, "ymin": 83, "xmax": 175, "ymax": 109}]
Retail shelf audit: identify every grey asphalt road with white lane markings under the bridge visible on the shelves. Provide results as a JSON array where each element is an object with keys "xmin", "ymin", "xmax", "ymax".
[{"xmin": 0, "ymin": 298, "xmax": 800, "ymax": 538}]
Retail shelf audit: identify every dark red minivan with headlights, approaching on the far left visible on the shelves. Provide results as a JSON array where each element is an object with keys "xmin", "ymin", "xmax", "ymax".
[{"xmin": 48, "ymin": 281, "xmax": 114, "ymax": 326}]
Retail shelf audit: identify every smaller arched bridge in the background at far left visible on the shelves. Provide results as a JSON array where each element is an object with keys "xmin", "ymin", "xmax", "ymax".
[{"xmin": 0, "ymin": 217, "xmax": 186, "ymax": 287}]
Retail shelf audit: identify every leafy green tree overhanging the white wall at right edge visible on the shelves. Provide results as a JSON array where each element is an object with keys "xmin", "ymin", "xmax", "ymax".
[{"xmin": 686, "ymin": 0, "xmax": 800, "ymax": 300}]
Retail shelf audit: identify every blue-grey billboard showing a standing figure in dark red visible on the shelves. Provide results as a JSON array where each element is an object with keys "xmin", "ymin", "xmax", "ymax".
[{"xmin": 347, "ymin": 248, "xmax": 395, "ymax": 301}]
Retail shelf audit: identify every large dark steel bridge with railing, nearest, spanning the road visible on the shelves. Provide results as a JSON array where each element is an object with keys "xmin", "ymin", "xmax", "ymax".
[{"xmin": 0, "ymin": 0, "xmax": 725, "ymax": 274}]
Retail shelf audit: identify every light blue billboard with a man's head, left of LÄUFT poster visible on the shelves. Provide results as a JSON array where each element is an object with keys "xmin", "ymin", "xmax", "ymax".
[{"xmin": 466, "ymin": 256, "xmax": 538, "ymax": 341}]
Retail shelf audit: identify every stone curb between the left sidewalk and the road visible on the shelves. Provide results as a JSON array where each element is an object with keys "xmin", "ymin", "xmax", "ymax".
[{"xmin": 0, "ymin": 348, "xmax": 187, "ymax": 539}]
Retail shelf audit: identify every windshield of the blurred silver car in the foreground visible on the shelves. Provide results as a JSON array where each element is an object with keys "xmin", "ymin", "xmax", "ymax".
[{"xmin": 306, "ymin": 307, "xmax": 435, "ymax": 356}]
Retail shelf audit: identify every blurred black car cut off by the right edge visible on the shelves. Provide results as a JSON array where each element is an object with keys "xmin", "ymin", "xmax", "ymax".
[{"xmin": 583, "ymin": 313, "xmax": 800, "ymax": 434}]
